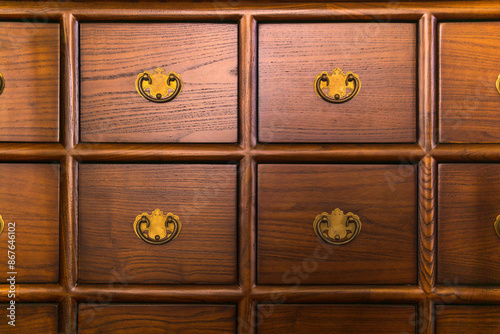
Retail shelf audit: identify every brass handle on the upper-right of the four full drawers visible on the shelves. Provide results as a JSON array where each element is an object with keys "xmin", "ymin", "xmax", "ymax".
[{"xmin": 314, "ymin": 67, "xmax": 361, "ymax": 103}]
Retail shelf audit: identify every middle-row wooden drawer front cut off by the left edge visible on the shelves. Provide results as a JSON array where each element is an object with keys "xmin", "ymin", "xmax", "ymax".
[{"xmin": 0, "ymin": 163, "xmax": 59, "ymax": 283}]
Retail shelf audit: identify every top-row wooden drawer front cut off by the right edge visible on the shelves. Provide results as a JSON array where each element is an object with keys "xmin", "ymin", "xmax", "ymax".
[{"xmin": 439, "ymin": 22, "xmax": 500, "ymax": 143}]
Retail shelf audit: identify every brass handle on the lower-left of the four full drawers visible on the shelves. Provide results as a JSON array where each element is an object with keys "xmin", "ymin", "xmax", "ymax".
[{"xmin": 134, "ymin": 209, "xmax": 181, "ymax": 245}]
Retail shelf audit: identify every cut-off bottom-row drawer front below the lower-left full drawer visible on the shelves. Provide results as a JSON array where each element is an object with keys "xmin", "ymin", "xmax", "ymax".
[{"xmin": 78, "ymin": 304, "xmax": 236, "ymax": 334}]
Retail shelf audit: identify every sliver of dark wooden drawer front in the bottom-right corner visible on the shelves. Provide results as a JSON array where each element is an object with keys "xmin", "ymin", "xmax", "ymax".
[{"xmin": 436, "ymin": 305, "xmax": 500, "ymax": 334}]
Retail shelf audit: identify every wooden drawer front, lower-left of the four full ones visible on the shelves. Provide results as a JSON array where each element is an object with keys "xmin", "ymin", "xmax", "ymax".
[{"xmin": 78, "ymin": 164, "xmax": 237, "ymax": 284}]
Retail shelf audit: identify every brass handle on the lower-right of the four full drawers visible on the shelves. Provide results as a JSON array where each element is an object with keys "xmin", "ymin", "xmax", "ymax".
[{"xmin": 313, "ymin": 209, "xmax": 361, "ymax": 245}]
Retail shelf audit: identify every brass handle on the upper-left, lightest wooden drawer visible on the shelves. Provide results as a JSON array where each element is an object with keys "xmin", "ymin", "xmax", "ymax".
[{"xmin": 135, "ymin": 67, "xmax": 182, "ymax": 103}]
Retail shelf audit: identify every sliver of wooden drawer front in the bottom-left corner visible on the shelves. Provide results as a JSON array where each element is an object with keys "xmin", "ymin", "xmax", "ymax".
[{"xmin": 0, "ymin": 304, "xmax": 58, "ymax": 334}]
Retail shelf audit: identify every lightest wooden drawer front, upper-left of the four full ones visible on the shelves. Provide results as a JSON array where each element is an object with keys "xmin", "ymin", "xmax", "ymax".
[{"xmin": 80, "ymin": 23, "xmax": 238, "ymax": 143}]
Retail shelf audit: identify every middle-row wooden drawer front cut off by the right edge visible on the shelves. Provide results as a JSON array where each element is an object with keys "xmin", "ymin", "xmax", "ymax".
[{"xmin": 437, "ymin": 164, "xmax": 500, "ymax": 284}]
